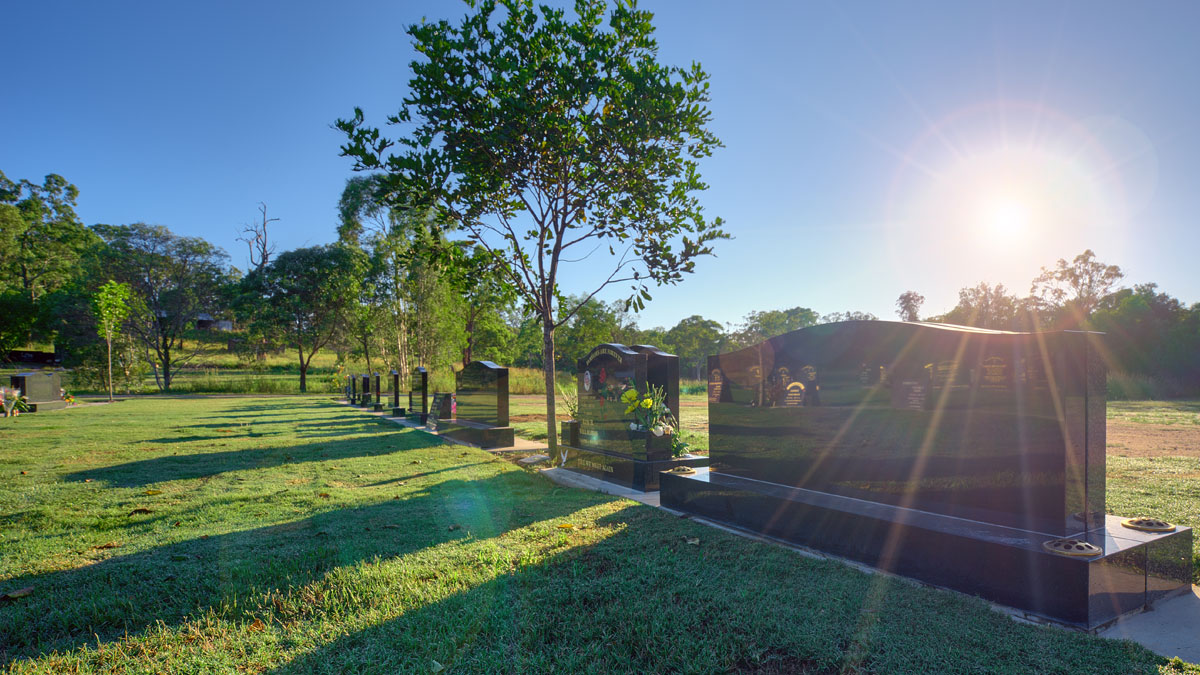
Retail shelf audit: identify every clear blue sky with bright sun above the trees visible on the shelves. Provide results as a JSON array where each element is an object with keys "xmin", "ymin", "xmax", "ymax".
[{"xmin": 0, "ymin": 0, "xmax": 1200, "ymax": 327}]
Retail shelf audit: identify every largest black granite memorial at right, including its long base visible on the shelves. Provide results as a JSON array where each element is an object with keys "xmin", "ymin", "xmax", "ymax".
[{"xmin": 661, "ymin": 321, "xmax": 1192, "ymax": 629}]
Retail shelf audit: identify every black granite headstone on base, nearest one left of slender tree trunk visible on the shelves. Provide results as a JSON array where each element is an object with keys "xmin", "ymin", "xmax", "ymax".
[{"xmin": 438, "ymin": 362, "xmax": 515, "ymax": 448}]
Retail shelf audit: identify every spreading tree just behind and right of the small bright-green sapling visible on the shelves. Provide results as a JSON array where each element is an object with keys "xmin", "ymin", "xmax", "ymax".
[{"xmin": 92, "ymin": 222, "xmax": 234, "ymax": 392}]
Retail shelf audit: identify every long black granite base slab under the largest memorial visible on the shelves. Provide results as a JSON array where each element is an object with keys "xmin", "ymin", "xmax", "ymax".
[{"xmin": 660, "ymin": 468, "xmax": 1192, "ymax": 631}]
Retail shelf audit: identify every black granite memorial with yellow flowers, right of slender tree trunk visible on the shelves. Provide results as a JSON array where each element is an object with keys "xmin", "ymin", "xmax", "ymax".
[{"xmin": 562, "ymin": 344, "xmax": 708, "ymax": 491}]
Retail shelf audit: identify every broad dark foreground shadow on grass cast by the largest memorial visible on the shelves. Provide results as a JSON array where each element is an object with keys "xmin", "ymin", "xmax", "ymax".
[{"xmin": 271, "ymin": 506, "xmax": 1166, "ymax": 675}]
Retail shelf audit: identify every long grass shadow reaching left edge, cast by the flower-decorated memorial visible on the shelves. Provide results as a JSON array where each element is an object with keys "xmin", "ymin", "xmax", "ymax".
[{"xmin": 0, "ymin": 466, "xmax": 604, "ymax": 665}]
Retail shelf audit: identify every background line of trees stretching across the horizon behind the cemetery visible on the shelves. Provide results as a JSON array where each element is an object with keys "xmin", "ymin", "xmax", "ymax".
[{"xmin": 0, "ymin": 166, "xmax": 1200, "ymax": 396}]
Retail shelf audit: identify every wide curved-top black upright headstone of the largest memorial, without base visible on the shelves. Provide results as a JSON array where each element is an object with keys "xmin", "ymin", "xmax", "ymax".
[{"xmin": 708, "ymin": 321, "xmax": 1105, "ymax": 533}]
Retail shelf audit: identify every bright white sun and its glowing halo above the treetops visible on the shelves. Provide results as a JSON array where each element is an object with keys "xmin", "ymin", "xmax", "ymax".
[{"xmin": 888, "ymin": 101, "xmax": 1157, "ymax": 273}]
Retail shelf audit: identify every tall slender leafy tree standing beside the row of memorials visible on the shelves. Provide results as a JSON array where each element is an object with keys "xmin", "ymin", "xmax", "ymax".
[{"xmin": 337, "ymin": 0, "xmax": 727, "ymax": 454}]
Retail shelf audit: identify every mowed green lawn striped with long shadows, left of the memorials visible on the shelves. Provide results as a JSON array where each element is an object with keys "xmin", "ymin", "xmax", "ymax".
[{"xmin": 0, "ymin": 398, "xmax": 1200, "ymax": 674}]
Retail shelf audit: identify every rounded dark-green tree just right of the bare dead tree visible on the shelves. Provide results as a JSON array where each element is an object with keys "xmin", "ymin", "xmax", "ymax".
[{"xmin": 240, "ymin": 244, "xmax": 365, "ymax": 392}]
